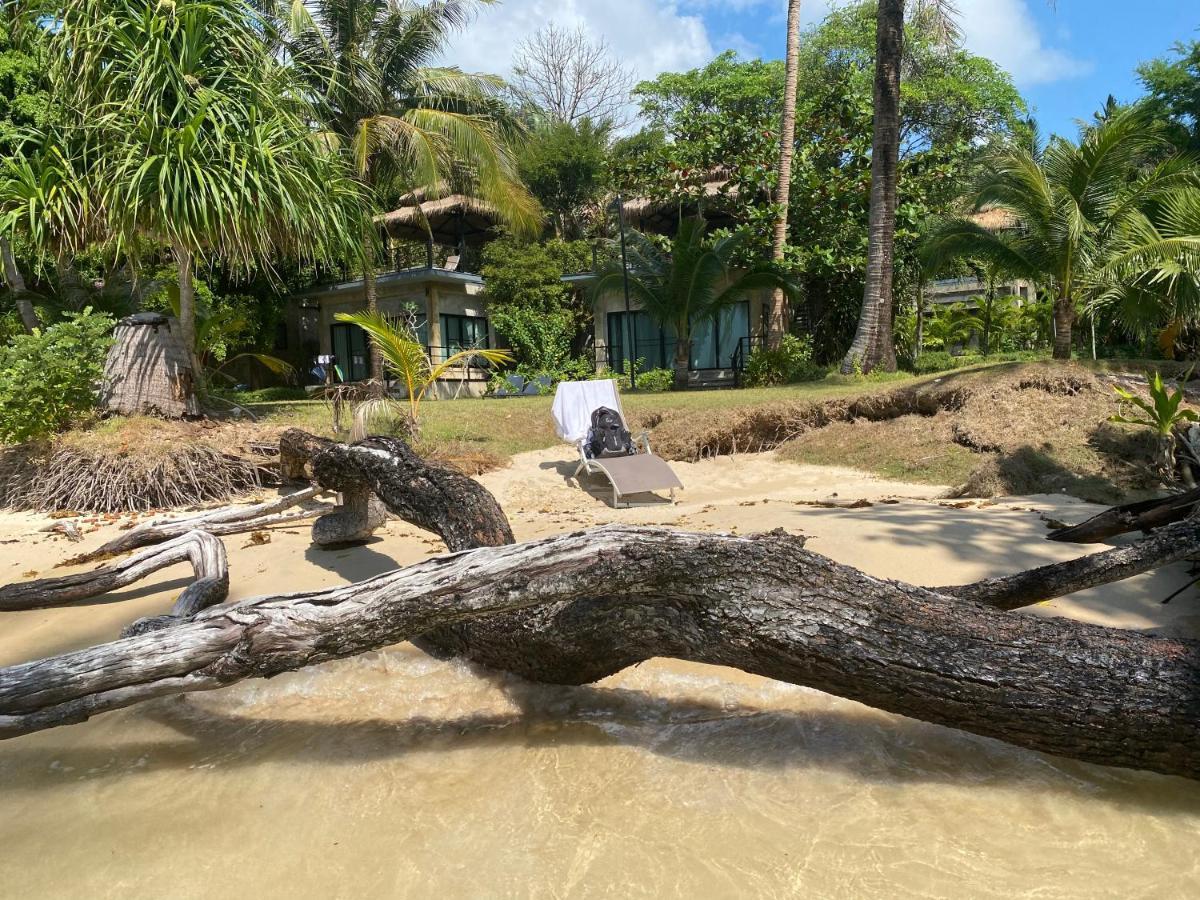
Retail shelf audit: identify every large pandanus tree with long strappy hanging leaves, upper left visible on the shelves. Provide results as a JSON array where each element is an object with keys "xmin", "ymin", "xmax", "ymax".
[{"xmin": 0, "ymin": 0, "xmax": 362, "ymax": 362}]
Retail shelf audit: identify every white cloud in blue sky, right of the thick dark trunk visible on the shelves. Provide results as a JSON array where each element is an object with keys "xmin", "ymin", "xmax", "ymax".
[{"xmin": 958, "ymin": 0, "xmax": 1093, "ymax": 88}]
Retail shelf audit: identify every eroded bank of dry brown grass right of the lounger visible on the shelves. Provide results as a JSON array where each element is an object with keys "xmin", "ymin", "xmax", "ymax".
[{"xmin": 643, "ymin": 362, "xmax": 1154, "ymax": 503}]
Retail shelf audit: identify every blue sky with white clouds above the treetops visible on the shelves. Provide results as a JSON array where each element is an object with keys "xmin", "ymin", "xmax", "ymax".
[{"xmin": 449, "ymin": 0, "xmax": 1200, "ymax": 134}]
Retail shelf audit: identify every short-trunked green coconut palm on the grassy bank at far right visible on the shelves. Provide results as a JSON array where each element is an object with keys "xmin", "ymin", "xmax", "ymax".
[{"xmin": 923, "ymin": 108, "xmax": 1195, "ymax": 359}]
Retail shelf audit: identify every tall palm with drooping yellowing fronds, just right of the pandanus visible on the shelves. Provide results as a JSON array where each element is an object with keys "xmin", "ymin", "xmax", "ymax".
[{"xmin": 268, "ymin": 0, "xmax": 541, "ymax": 380}]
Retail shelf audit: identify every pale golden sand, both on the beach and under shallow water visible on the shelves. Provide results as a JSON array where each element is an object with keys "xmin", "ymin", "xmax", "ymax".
[{"xmin": 0, "ymin": 450, "xmax": 1200, "ymax": 898}]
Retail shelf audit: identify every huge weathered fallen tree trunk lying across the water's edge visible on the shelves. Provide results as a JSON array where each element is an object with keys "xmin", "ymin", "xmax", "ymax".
[{"xmin": 0, "ymin": 438, "xmax": 1200, "ymax": 778}]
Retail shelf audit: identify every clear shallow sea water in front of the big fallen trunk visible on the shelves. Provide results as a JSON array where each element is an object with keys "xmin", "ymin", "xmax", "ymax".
[{"xmin": 0, "ymin": 644, "xmax": 1200, "ymax": 899}]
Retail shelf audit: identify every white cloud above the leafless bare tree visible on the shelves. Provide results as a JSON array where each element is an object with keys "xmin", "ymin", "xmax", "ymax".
[{"xmin": 446, "ymin": 0, "xmax": 715, "ymax": 84}]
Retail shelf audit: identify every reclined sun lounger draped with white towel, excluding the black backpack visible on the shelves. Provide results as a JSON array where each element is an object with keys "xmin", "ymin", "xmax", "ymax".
[{"xmin": 551, "ymin": 379, "xmax": 683, "ymax": 506}]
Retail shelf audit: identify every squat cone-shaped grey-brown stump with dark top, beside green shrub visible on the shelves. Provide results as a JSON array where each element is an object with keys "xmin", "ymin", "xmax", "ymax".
[{"xmin": 100, "ymin": 312, "xmax": 202, "ymax": 419}]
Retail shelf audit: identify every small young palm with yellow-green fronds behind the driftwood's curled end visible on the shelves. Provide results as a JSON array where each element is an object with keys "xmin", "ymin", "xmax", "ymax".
[{"xmin": 336, "ymin": 310, "xmax": 512, "ymax": 437}]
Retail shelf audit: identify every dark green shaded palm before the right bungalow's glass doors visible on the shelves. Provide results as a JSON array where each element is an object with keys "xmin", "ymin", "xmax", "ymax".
[{"xmin": 592, "ymin": 216, "xmax": 797, "ymax": 390}]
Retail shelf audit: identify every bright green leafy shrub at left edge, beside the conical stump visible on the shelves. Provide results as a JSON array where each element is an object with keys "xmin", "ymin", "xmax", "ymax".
[{"xmin": 0, "ymin": 308, "xmax": 113, "ymax": 443}]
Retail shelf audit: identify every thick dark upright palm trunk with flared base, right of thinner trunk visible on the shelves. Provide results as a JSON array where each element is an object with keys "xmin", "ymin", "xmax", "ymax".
[{"xmin": 841, "ymin": 0, "xmax": 904, "ymax": 374}]
